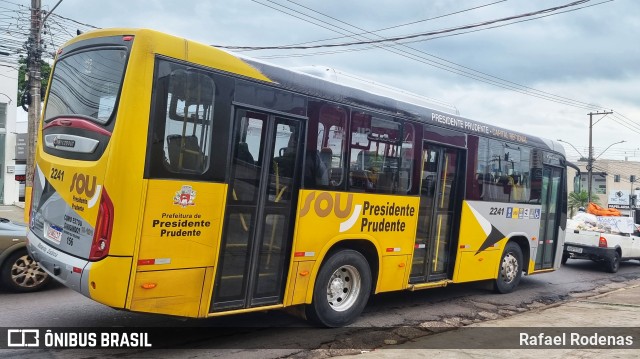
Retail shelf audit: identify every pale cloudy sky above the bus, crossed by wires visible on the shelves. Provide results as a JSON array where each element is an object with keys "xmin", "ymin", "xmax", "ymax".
[{"xmin": 50, "ymin": 0, "xmax": 640, "ymax": 160}]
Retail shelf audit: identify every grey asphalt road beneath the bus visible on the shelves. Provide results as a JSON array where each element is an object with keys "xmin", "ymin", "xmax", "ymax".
[{"xmin": 0, "ymin": 260, "xmax": 640, "ymax": 358}]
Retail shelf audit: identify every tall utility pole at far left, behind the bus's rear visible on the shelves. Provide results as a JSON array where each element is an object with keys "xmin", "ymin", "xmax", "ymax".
[{"xmin": 25, "ymin": 0, "xmax": 42, "ymax": 197}]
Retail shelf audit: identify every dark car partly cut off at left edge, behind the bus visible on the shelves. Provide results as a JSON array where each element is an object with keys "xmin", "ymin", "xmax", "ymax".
[{"xmin": 0, "ymin": 218, "xmax": 51, "ymax": 292}]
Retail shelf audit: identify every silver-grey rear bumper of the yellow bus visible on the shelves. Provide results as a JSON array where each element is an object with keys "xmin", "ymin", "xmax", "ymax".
[{"xmin": 27, "ymin": 230, "xmax": 91, "ymax": 298}]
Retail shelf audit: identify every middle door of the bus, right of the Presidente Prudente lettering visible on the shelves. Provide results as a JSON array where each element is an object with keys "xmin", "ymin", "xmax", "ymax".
[{"xmin": 410, "ymin": 142, "xmax": 464, "ymax": 283}]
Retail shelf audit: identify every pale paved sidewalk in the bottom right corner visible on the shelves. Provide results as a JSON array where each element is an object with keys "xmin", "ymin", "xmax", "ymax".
[{"xmin": 334, "ymin": 280, "xmax": 640, "ymax": 359}]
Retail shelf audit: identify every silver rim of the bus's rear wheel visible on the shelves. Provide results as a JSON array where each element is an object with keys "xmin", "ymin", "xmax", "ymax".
[{"xmin": 327, "ymin": 265, "xmax": 362, "ymax": 312}]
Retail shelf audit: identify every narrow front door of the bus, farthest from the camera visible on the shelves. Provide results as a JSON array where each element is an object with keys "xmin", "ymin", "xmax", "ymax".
[{"xmin": 535, "ymin": 165, "xmax": 563, "ymax": 270}]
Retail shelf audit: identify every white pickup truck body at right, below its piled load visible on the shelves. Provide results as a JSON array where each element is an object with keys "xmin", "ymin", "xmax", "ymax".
[{"xmin": 562, "ymin": 228, "xmax": 640, "ymax": 273}]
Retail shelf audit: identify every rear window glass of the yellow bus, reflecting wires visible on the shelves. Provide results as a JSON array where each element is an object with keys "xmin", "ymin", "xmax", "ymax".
[{"xmin": 44, "ymin": 48, "xmax": 127, "ymax": 124}]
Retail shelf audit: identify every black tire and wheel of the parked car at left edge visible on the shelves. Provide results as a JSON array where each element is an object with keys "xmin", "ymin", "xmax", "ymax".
[{"xmin": 0, "ymin": 249, "xmax": 51, "ymax": 293}]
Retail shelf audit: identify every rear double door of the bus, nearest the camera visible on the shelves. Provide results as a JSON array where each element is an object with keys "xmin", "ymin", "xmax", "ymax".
[{"xmin": 210, "ymin": 109, "xmax": 303, "ymax": 312}]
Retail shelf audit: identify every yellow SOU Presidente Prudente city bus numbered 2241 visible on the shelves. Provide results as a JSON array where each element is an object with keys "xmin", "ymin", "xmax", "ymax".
[{"xmin": 28, "ymin": 29, "xmax": 567, "ymax": 327}]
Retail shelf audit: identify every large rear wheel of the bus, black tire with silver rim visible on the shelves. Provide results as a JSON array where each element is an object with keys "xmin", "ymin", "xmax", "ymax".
[{"xmin": 305, "ymin": 249, "xmax": 371, "ymax": 328}]
